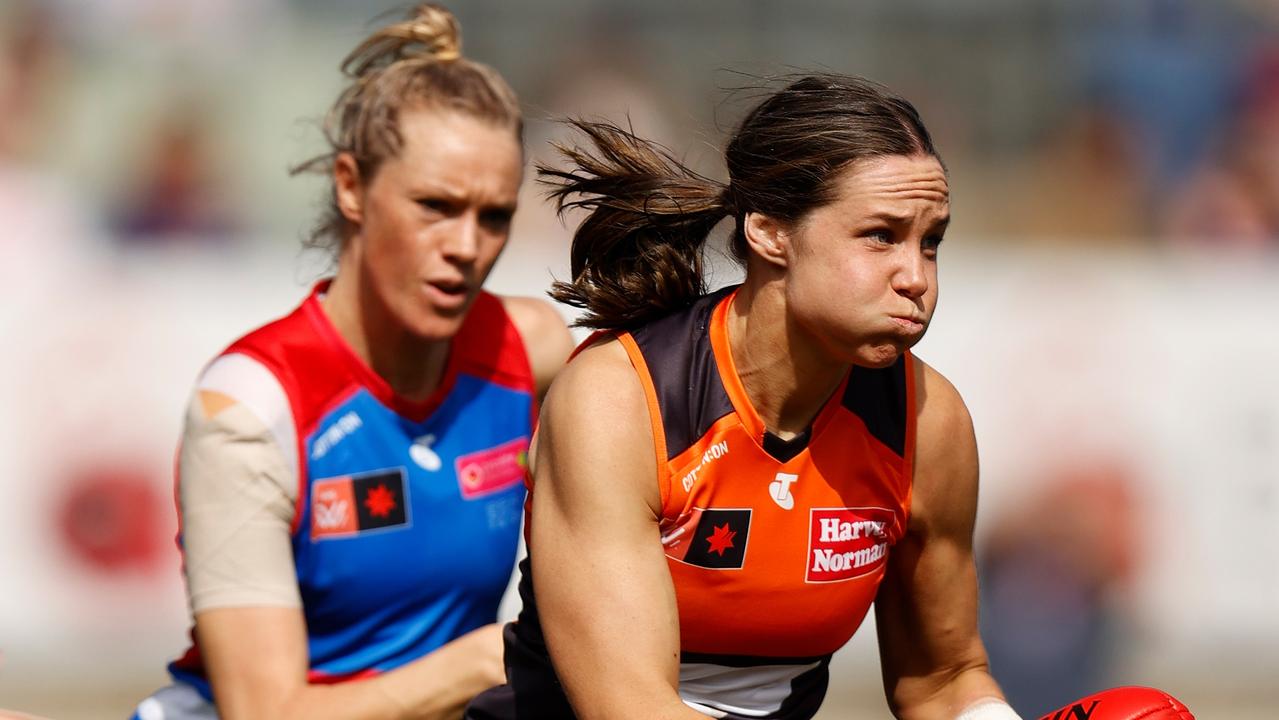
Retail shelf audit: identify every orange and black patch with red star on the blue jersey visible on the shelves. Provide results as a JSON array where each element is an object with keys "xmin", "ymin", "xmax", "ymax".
[{"xmin": 311, "ymin": 468, "xmax": 408, "ymax": 540}]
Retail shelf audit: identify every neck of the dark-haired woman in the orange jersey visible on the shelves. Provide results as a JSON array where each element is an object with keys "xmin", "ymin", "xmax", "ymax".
[{"xmin": 728, "ymin": 276, "xmax": 849, "ymax": 440}]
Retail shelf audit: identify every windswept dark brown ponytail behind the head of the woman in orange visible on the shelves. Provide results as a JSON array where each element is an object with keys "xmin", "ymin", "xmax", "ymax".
[{"xmin": 537, "ymin": 120, "xmax": 732, "ymax": 329}]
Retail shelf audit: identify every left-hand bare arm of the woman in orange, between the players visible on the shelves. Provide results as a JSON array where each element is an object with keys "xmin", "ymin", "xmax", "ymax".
[{"xmin": 530, "ymin": 341, "xmax": 705, "ymax": 720}]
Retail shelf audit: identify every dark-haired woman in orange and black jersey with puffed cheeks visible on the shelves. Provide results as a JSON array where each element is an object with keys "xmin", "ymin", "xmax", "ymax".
[{"xmin": 467, "ymin": 75, "xmax": 1017, "ymax": 720}]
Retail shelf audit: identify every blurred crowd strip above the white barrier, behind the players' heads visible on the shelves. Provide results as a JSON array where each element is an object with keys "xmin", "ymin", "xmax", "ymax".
[{"xmin": 0, "ymin": 0, "xmax": 1279, "ymax": 259}]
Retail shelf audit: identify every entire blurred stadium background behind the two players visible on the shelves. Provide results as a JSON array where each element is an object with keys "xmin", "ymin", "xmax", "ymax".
[{"xmin": 0, "ymin": 0, "xmax": 1279, "ymax": 720}]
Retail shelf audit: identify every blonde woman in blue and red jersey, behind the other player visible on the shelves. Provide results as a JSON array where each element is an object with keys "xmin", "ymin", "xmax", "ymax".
[{"xmin": 137, "ymin": 5, "xmax": 570, "ymax": 720}]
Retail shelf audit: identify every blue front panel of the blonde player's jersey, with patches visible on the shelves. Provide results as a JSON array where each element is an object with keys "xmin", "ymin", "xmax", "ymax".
[{"xmin": 294, "ymin": 375, "xmax": 532, "ymax": 675}]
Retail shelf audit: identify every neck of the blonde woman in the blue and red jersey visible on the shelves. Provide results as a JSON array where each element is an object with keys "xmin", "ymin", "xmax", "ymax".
[{"xmin": 321, "ymin": 254, "xmax": 449, "ymax": 400}]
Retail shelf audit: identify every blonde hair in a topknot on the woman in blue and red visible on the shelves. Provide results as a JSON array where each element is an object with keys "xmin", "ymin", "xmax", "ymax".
[{"xmin": 292, "ymin": 3, "xmax": 523, "ymax": 247}]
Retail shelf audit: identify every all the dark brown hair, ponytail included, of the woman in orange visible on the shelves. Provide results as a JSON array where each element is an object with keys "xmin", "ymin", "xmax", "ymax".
[{"xmin": 549, "ymin": 74, "xmax": 940, "ymax": 330}]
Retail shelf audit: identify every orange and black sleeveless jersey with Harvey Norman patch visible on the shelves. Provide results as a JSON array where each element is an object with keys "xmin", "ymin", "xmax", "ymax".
[{"xmin": 466, "ymin": 288, "xmax": 914, "ymax": 720}]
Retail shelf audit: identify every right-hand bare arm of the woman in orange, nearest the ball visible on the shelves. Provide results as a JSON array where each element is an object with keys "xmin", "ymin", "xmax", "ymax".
[{"xmin": 875, "ymin": 358, "xmax": 1003, "ymax": 720}]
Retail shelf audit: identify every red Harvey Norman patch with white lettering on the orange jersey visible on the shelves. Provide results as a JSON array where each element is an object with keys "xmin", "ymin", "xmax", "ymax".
[{"xmin": 804, "ymin": 508, "xmax": 895, "ymax": 582}]
